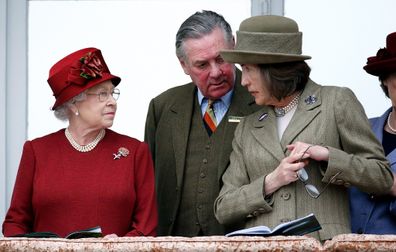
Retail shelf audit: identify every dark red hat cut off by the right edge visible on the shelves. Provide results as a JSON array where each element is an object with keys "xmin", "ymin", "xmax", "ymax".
[{"xmin": 363, "ymin": 32, "xmax": 396, "ymax": 76}]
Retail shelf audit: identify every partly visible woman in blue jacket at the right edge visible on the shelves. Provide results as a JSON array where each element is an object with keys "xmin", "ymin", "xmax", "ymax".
[{"xmin": 349, "ymin": 32, "xmax": 396, "ymax": 234}]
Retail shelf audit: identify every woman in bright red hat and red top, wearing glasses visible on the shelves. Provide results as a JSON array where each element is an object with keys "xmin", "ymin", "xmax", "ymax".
[{"xmin": 3, "ymin": 48, "xmax": 157, "ymax": 237}]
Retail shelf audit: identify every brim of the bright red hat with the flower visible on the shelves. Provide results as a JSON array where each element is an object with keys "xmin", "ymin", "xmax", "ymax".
[{"xmin": 52, "ymin": 73, "xmax": 121, "ymax": 110}]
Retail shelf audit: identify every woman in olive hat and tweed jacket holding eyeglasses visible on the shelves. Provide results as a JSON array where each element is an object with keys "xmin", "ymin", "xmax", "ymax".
[{"xmin": 215, "ymin": 16, "xmax": 393, "ymax": 240}]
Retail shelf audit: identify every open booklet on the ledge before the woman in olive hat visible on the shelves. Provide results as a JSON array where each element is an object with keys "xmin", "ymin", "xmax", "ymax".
[{"xmin": 226, "ymin": 213, "xmax": 322, "ymax": 236}]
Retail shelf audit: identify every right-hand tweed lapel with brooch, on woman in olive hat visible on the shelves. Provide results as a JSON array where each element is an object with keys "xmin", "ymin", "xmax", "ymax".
[{"xmin": 281, "ymin": 80, "xmax": 322, "ymax": 151}]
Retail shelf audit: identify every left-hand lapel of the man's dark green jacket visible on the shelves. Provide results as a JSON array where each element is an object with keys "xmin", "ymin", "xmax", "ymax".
[{"xmin": 170, "ymin": 84, "xmax": 197, "ymax": 187}]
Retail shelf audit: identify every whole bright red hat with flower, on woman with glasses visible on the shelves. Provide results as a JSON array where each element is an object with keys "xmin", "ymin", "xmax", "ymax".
[{"xmin": 48, "ymin": 48, "xmax": 121, "ymax": 110}]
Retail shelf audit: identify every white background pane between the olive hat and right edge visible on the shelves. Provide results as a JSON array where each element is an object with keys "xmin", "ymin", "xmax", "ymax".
[{"xmin": 285, "ymin": 0, "xmax": 396, "ymax": 117}]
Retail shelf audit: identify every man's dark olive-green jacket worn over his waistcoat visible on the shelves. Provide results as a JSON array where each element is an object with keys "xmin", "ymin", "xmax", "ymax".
[{"xmin": 145, "ymin": 70, "xmax": 259, "ymax": 235}]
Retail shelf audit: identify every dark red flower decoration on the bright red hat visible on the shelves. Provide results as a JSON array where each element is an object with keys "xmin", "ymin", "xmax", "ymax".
[{"xmin": 67, "ymin": 52, "xmax": 104, "ymax": 85}]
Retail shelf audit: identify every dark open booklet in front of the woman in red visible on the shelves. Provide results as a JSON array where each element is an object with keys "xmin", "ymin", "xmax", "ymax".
[{"xmin": 13, "ymin": 226, "xmax": 103, "ymax": 239}]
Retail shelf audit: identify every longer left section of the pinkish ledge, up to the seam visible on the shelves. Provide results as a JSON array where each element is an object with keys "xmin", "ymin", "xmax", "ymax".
[{"xmin": 0, "ymin": 236, "xmax": 321, "ymax": 252}]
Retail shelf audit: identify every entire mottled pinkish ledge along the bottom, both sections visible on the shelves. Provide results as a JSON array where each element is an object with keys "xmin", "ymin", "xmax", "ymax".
[{"xmin": 0, "ymin": 234, "xmax": 396, "ymax": 252}]
